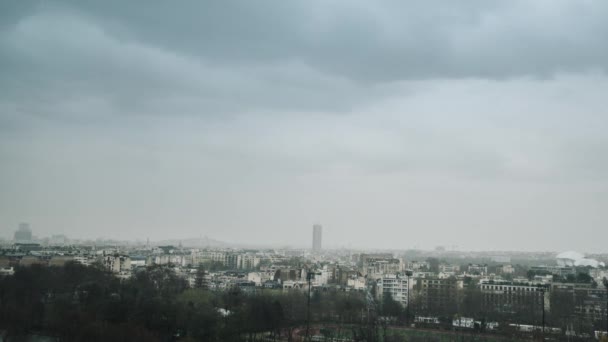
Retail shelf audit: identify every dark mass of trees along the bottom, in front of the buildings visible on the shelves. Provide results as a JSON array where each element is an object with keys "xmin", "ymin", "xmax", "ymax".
[{"xmin": 0, "ymin": 263, "xmax": 598, "ymax": 342}]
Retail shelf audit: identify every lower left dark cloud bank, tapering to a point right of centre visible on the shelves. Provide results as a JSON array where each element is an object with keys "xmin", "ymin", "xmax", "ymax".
[{"xmin": 0, "ymin": 3, "xmax": 388, "ymax": 117}]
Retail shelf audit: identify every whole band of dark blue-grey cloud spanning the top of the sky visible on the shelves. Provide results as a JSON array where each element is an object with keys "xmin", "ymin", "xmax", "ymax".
[{"xmin": 0, "ymin": 1, "xmax": 608, "ymax": 121}]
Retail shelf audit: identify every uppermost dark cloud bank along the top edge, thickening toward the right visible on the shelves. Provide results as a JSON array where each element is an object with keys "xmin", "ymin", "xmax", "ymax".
[{"xmin": 5, "ymin": 0, "xmax": 608, "ymax": 82}]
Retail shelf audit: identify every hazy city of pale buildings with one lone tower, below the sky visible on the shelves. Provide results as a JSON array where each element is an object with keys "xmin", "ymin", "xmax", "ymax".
[{"xmin": 0, "ymin": 223, "xmax": 608, "ymax": 341}]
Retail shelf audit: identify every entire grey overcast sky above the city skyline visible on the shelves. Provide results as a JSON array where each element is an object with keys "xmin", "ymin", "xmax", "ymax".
[{"xmin": 0, "ymin": 0, "xmax": 608, "ymax": 252}]
